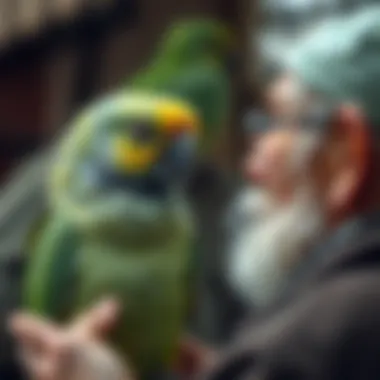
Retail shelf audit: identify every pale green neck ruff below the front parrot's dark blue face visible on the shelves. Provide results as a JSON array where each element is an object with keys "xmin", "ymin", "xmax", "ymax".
[{"xmin": 55, "ymin": 192, "xmax": 190, "ymax": 246}]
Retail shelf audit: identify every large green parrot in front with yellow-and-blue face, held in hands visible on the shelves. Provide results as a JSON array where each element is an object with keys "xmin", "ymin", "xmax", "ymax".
[{"xmin": 24, "ymin": 92, "xmax": 201, "ymax": 379}]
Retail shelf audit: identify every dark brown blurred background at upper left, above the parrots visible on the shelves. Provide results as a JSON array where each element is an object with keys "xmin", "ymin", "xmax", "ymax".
[{"xmin": 0, "ymin": 0, "xmax": 246, "ymax": 181}]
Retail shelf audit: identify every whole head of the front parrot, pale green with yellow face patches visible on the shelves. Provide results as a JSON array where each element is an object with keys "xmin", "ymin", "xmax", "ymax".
[{"xmin": 50, "ymin": 92, "xmax": 200, "ymax": 238}]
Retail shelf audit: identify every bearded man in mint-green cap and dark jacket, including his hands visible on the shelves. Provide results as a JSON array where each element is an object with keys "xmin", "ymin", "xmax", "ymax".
[{"xmin": 11, "ymin": 6, "xmax": 380, "ymax": 380}]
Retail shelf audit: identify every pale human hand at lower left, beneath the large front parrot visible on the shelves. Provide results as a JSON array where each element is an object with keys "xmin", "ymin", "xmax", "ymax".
[{"xmin": 10, "ymin": 300, "xmax": 133, "ymax": 380}]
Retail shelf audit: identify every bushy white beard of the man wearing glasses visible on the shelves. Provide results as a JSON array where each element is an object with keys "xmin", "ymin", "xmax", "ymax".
[{"xmin": 228, "ymin": 189, "xmax": 324, "ymax": 308}]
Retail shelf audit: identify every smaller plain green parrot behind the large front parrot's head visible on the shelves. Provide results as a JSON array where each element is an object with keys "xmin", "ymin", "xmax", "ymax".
[{"xmin": 126, "ymin": 18, "xmax": 236, "ymax": 155}]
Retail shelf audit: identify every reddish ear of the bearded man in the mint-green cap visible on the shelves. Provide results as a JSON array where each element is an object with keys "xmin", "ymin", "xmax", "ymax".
[{"xmin": 328, "ymin": 104, "xmax": 371, "ymax": 211}]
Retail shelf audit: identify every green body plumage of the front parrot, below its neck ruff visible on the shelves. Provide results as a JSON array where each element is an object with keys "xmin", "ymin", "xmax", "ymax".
[{"xmin": 25, "ymin": 203, "xmax": 192, "ymax": 373}]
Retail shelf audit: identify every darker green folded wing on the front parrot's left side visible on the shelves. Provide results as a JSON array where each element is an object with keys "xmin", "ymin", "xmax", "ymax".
[{"xmin": 24, "ymin": 218, "xmax": 79, "ymax": 321}]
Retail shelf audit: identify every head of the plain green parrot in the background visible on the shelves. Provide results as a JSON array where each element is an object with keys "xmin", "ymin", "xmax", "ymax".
[{"xmin": 159, "ymin": 19, "xmax": 236, "ymax": 65}]
